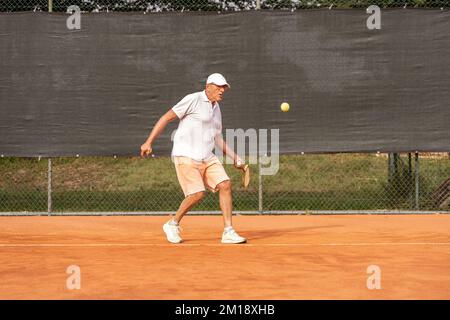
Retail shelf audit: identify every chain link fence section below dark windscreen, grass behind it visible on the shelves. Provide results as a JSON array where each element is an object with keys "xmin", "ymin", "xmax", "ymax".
[{"xmin": 0, "ymin": 153, "xmax": 450, "ymax": 214}]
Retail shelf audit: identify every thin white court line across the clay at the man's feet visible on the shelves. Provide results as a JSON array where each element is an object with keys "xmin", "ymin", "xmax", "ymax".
[{"xmin": 0, "ymin": 242, "xmax": 450, "ymax": 248}]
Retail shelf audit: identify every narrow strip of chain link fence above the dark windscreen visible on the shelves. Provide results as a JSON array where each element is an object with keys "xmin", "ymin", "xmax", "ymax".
[{"xmin": 0, "ymin": 0, "xmax": 450, "ymax": 12}]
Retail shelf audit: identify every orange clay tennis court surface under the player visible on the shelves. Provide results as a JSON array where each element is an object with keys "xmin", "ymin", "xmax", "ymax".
[{"xmin": 0, "ymin": 215, "xmax": 450, "ymax": 300}]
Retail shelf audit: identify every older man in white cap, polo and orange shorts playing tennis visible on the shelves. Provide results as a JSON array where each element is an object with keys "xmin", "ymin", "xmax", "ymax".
[{"xmin": 141, "ymin": 73, "xmax": 246, "ymax": 243}]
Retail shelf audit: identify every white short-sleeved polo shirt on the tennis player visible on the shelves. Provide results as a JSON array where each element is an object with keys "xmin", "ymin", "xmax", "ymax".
[{"xmin": 172, "ymin": 90, "xmax": 222, "ymax": 161}]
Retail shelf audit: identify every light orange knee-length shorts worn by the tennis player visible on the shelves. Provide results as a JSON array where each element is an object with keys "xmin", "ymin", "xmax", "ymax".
[{"xmin": 173, "ymin": 157, "xmax": 230, "ymax": 197}]
